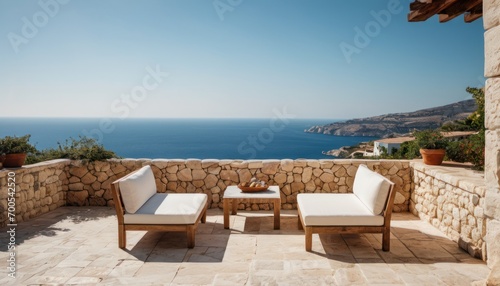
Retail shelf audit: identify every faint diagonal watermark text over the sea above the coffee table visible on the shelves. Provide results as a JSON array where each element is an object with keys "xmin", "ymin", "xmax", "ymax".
[{"xmin": 238, "ymin": 106, "xmax": 296, "ymax": 159}]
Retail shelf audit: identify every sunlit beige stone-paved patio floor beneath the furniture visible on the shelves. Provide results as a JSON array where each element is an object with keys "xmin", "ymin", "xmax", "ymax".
[{"xmin": 0, "ymin": 207, "xmax": 489, "ymax": 286}]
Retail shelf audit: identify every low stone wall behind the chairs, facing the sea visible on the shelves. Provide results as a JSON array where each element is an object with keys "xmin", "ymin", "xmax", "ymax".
[{"xmin": 67, "ymin": 159, "xmax": 411, "ymax": 212}]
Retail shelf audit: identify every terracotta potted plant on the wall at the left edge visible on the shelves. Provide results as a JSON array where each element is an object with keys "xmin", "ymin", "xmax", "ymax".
[{"xmin": 0, "ymin": 135, "xmax": 36, "ymax": 168}]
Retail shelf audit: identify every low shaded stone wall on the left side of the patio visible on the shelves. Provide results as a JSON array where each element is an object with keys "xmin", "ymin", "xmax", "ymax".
[{"xmin": 0, "ymin": 160, "xmax": 70, "ymax": 227}]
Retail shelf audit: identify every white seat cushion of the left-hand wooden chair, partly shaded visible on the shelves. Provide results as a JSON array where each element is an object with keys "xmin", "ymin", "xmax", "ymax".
[{"xmin": 123, "ymin": 193, "xmax": 208, "ymax": 224}]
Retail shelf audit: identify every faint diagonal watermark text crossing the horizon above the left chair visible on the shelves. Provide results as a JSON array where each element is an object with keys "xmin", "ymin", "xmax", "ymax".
[{"xmin": 82, "ymin": 65, "xmax": 169, "ymax": 143}]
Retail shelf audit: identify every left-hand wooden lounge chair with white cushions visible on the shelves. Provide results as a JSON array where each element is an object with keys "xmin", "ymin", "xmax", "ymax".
[{"xmin": 111, "ymin": 166, "xmax": 208, "ymax": 248}]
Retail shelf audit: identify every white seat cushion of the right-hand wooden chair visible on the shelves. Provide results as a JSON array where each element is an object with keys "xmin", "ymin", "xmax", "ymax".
[{"xmin": 297, "ymin": 193, "xmax": 384, "ymax": 226}]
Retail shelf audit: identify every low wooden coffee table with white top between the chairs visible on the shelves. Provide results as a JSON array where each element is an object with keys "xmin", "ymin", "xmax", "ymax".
[{"xmin": 222, "ymin": 186, "xmax": 281, "ymax": 229}]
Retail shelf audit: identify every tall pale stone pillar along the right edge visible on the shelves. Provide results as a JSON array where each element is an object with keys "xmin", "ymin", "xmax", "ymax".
[{"xmin": 483, "ymin": 0, "xmax": 500, "ymax": 280}]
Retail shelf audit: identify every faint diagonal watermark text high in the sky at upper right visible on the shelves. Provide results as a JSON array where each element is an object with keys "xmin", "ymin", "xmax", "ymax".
[{"xmin": 339, "ymin": 0, "xmax": 404, "ymax": 64}]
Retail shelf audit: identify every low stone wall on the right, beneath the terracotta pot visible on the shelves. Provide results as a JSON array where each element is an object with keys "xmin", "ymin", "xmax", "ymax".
[{"xmin": 410, "ymin": 162, "xmax": 486, "ymax": 260}]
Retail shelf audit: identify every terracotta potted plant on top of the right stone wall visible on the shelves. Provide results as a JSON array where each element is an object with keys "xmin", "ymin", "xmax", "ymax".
[{"xmin": 413, "ymin": 130, "xmax": 448, "ymax": 165}]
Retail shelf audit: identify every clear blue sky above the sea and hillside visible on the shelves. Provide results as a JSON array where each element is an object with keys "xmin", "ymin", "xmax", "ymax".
[{"xmin": 0, "ymin": 0, "xmax": 484, "ymax": 119}]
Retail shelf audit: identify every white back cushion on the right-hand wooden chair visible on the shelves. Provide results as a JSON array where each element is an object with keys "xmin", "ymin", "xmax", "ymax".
[{"xmin": 353, "ymin": 165, "xmax": 391, "ymax": 215}]
